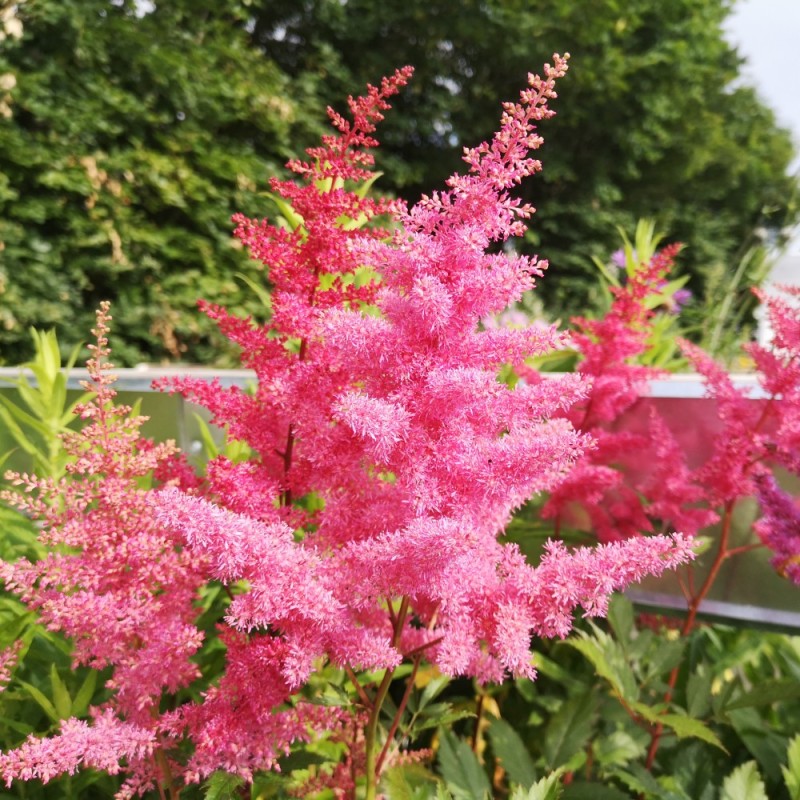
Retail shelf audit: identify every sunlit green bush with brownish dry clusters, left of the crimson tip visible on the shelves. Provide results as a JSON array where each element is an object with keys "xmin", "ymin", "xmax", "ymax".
[{"xmin": 0, "ymin": 0, "xmax": 324, "ymax": 364}]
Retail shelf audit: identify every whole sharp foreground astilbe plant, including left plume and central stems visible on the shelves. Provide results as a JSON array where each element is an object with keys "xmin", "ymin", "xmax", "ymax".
[{"xmin": 3, "ymin": 56, "xmax": 693, "ymax": 798}]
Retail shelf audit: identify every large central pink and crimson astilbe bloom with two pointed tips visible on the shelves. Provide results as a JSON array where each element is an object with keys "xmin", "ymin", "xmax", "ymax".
[{"xmin": 157, "ymin": 56, "xmax": 691, "ymax": 788}]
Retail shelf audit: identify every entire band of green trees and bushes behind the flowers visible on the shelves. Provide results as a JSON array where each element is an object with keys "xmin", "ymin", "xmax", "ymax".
[{"xmin": 0, "ymin": 0, "xmax": 798, "ymax": 363}]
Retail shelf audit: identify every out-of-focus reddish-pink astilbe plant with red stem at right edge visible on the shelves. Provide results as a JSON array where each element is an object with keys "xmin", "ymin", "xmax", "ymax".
[{"xmin": 522, "ymin": 252, "xmax": 800, "ymax": 770}]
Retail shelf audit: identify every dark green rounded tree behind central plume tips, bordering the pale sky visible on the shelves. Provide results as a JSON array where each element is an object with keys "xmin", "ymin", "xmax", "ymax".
[{"xmin": 254, "ymin": 0, "xmax": 798, "ymax": 332}]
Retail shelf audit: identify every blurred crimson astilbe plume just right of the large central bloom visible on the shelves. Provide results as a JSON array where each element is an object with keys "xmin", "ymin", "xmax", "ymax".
[{"xmin": 542, "ymin": 244, "xmax": 716, "ymax": 542}]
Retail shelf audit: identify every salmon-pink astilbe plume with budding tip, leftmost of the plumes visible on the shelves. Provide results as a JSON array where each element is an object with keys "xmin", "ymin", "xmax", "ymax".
[{"xmin": 0, "ymin": 304, "xmax": 203, "ymax": 783}]
